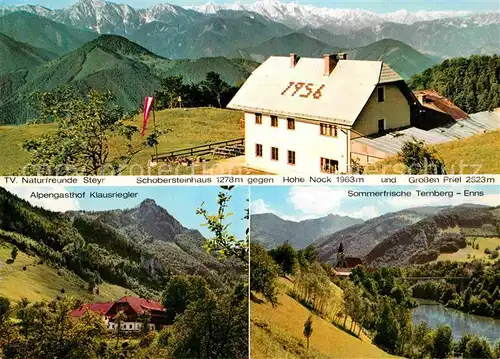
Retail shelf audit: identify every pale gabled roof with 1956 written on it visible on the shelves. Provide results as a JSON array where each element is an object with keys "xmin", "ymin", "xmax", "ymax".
[{"xmin": 228, "ymin": 56, "xmax": 403, "ymax": 126}]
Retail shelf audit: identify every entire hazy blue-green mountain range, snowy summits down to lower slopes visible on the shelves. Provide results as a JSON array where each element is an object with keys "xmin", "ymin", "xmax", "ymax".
[{"xmin": 0, "ymin": 0, "xmax": 500, "ymax": 59}]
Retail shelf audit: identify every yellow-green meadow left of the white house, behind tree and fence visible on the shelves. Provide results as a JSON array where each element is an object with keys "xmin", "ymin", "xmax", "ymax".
[{"xmin": 0, "ymin": 108, "xmax": 243, "ymax": 175}]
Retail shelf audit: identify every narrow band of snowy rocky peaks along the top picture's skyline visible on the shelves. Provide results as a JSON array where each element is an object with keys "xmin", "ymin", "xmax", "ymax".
[{"xmin": 0, "ymin": 0, "xmax": 500, "ymax": 33}]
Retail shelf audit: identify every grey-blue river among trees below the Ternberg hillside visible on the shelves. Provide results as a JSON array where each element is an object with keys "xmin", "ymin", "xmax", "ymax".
[{"xmin": 412, "ymin": 300, "xmax": 500, "ymax": 343}]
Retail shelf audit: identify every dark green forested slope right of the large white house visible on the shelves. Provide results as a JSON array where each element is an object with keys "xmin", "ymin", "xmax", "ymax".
[{"xmin": 408, "ymin": 55, "xmax": 500, "ymax": 113}]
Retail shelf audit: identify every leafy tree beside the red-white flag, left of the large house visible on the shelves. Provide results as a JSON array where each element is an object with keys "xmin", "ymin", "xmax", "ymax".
[{"xmin": 22, "ymin": 87, "xmax": 158, "ymax": 176}]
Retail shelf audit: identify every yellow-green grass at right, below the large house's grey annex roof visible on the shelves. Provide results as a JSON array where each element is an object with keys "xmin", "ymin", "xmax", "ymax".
[{"xmin": 366, "ymin": 130, "xmax": 500, "ymax": 174}]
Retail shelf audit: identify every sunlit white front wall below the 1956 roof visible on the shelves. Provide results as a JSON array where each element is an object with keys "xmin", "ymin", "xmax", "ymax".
[{"xmin": 245, "ymin": 113, "xmax": 348, "ymax": 175}]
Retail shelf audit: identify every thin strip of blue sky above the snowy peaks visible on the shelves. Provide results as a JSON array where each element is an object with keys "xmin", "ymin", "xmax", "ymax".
[{"xmin": 0, "ymin": 0, "xmax": 500, "ymax": 13}]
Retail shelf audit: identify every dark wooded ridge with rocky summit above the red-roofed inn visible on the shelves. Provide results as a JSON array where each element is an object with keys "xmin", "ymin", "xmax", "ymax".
[{"xmin": 0, "ymin": 188, "xmax": 238, "ymax": 297}]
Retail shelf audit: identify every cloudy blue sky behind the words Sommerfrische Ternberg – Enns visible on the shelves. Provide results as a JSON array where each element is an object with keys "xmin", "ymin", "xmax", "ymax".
[{"xmin": 250, "ymin": 185, "xmax": 500, "ymax": 221}]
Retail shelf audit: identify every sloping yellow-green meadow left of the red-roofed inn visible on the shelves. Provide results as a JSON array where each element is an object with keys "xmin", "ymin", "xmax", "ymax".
[{"xmin": 0, "ymin": 242, "xmax": 134, "ymax": 302}]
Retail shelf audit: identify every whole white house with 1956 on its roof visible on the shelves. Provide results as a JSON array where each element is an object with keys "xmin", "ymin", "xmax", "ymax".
[{"xmin": 228, "ymin": 53, "xmax": 420, "ymax": 174}]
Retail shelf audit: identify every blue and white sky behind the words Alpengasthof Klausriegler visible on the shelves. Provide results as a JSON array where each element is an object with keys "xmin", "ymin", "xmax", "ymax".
[{"xmin": 1, "ymin": 186, "xmax": 248, "ymax": 238}]
